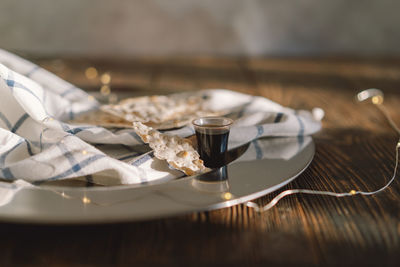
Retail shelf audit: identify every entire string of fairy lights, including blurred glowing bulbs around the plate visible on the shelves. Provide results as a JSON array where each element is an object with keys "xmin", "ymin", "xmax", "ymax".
[{"xmin": 41, "ymin": 67, "xmax": 400, "ymax": 213}]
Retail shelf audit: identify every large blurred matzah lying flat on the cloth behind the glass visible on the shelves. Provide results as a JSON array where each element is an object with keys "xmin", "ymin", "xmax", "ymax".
[{"xmin": 72, "ymin": 92, "xmax": 226, "ymax": 130}]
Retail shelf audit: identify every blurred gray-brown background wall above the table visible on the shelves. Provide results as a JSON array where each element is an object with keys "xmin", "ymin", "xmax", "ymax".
[{"xmin": 0, "ymin": 0, "xmax": 400, "ymax": 57}]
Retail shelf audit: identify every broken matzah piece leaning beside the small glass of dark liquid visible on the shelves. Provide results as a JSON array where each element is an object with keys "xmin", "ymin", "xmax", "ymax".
[{"xmin": 132, "ymin": 122, "xmax": 206, "ymax": 176}]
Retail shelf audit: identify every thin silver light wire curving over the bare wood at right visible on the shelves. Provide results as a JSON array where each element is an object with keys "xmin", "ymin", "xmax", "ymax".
[{"xmin": 246, "ymin": 89, "xmax": 400, "ymax": 213}]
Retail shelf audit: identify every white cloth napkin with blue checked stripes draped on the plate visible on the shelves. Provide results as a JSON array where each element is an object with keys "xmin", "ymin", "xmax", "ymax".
[{"xmin": 0, "ymin": 50, "xmax": 321, "ymax": 185}]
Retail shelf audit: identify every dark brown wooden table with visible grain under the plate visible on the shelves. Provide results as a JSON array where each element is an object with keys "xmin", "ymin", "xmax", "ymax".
[{"xmin": 0, "ymin": 58, "xmax": 400, "ymax": 266}]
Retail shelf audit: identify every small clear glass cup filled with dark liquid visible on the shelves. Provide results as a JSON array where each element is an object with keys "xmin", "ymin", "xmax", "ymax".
[{"xmin": 192, "ymin": 117, "xmax": 233, "ymax": 168}]
